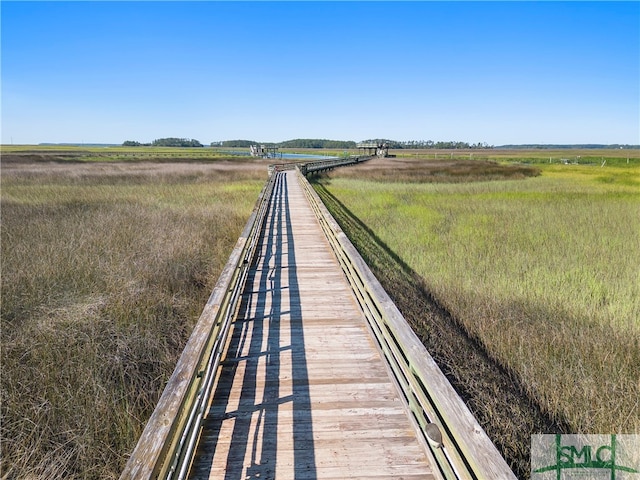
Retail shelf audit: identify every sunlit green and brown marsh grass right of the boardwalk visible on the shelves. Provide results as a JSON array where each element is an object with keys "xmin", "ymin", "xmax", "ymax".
[{"xmin": 318, "ymin": 158, "xmax": 640, "ymax": 472}]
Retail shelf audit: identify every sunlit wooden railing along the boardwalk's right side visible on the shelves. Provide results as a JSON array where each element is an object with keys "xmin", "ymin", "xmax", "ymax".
[{"xmin": 300, "ymin": 166, "xmax": 516, "ymax": 479}]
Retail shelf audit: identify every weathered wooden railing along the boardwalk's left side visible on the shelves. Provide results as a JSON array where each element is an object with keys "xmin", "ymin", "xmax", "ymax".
[{"xmin": 120, "ymin": 176, "xmax": 275, "ymax": 480}]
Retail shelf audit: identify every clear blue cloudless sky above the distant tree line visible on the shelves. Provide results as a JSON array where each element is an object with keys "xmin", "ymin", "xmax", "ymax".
[{"xmin": 0, "ymin": 1, "xmax": 640, "ymax": 145}]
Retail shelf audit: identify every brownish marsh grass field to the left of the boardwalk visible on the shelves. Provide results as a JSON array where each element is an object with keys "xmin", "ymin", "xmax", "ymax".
[{"xmin": 0, "ymin": 160, "xmax": 266, "ymax": 478}]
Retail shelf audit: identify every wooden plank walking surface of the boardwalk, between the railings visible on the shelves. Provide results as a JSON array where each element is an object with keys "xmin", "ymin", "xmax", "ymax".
[{"xmin": 189, "ymin": 171, "xmax": 439, "ymax": 480}]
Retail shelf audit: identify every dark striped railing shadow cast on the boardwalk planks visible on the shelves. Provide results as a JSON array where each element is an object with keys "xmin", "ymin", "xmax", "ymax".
[{"xmin": 191, "ymin": 175, "xmax": 317, "ymax": 480}]
